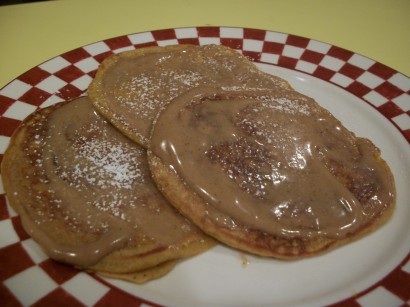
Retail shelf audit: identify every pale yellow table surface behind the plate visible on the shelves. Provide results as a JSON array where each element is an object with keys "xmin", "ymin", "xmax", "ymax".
[{"xmin": 0, "ymin": 0, "xmax": 410, "ymax": 88}]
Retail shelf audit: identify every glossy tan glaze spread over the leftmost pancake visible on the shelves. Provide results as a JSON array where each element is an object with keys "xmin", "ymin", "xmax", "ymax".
[{"xmin": 15, "ymin": 98, "xmax": 193, "ymax": 267}]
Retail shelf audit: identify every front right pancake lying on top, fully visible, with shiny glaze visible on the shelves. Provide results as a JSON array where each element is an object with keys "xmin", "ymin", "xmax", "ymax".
[{"xmin": 148, "ymin": 88, "xmax": 395, "ymax": 259}]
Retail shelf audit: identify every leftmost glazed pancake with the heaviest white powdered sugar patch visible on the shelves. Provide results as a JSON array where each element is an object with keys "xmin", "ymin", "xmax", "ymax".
[{"xmin": 1, "ymin": 97, "xmax": 214, "ymax": 281}]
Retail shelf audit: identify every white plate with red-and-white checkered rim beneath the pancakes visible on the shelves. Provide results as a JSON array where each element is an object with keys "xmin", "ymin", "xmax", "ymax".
[{"xmin": 0, "ymin": 27, "xmax": 410, "ymax": 306}]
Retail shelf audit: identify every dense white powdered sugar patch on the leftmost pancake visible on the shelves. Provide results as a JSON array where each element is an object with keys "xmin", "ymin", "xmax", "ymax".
[{"xmin": 55, "ymin": 118, "xmax": 144, "ymax": 195}]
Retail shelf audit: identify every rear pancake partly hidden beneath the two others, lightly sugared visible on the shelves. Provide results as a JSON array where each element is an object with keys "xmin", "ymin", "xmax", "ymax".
[{"xmin": 88, "ymin": 45, "xmax": 290, "ymax": 147}]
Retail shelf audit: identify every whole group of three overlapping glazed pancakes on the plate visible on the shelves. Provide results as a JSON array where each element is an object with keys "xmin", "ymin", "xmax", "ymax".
[{"xmin": 2, "ymin": 45, "xmax": 395, "ymax": 283}]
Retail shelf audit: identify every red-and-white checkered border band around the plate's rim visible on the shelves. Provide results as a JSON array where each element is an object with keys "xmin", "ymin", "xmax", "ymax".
[{"xmin": 0, "ymin": 27, "xmax": 410, "ymax": 307}]
